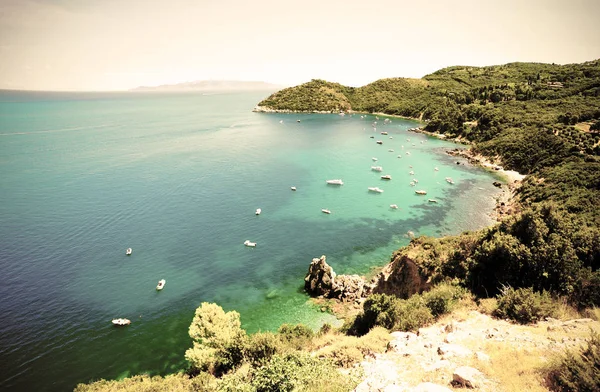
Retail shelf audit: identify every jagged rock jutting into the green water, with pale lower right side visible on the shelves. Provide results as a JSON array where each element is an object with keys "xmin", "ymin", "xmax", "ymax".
[{"xmin": 304, "ymin": 255, "xmax": 372, "ymax": 301}]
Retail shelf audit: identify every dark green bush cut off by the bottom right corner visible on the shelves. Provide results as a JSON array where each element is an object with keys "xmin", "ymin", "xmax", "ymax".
[{"xmin": 546, "ymin": 331, "xmax": 600, "ymax": 392}]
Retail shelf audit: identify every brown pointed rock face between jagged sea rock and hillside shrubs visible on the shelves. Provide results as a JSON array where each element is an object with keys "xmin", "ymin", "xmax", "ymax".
[{"xmin": 373, "ymin": 254, "xmax": 431, "ymax": 298}]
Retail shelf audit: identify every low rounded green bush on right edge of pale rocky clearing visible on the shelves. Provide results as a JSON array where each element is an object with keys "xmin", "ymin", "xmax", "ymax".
[{"xmin": 496, "ymin": 286, "xmax": 553, "ymax": 324}]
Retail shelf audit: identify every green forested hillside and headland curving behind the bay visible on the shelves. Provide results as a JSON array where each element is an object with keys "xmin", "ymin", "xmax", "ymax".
[{"xmin": 258, "ymin": 60, "xmax": 600, "ymax": 222}]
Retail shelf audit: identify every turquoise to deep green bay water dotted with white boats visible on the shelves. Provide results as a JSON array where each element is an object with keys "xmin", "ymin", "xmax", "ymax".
[{"xmin": 0, "ymin": 92, "xmax": 497, "ymax": 391}]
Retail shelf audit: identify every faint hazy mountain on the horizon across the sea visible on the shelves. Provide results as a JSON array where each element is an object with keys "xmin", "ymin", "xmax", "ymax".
[{"xmin": 130, "ymin": 80, "xmax": 283, "ymax": 91}]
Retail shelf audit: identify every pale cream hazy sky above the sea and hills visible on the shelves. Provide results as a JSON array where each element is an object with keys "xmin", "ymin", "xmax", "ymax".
[{"xmin": 0, "ymin": 0, "xmax": 600, "ymax": 91}]
